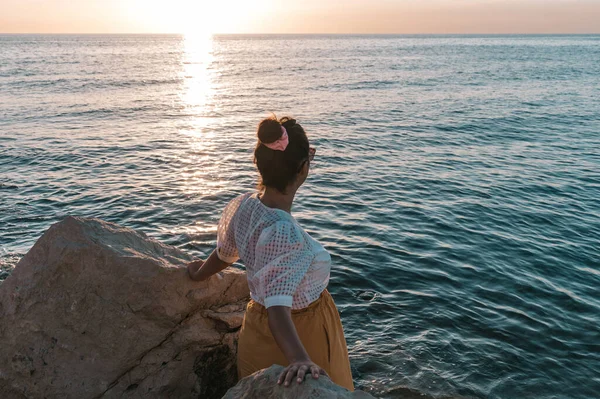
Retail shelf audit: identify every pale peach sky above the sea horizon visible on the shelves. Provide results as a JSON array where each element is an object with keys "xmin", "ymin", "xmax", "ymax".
[{"xmin": 0, "ymin": 0, "xmax": 600, "ymax": 35}]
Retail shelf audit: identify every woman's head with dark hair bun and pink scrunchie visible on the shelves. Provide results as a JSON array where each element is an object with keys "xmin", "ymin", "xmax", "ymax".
[{"xmin": 254, "ymin": 115, "xmax": 310, "ymax": 193}]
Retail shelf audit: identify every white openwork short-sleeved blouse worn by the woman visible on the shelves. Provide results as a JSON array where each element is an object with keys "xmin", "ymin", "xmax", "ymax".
[{"xmin": 217, "ymin": 192, "xmax": 331, "ymax": 309}]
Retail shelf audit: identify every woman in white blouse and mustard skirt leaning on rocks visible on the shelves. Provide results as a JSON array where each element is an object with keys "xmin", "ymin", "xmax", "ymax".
[{"xmin": 188, "ymin": 117, "xmax": 354, "ymax": 390}]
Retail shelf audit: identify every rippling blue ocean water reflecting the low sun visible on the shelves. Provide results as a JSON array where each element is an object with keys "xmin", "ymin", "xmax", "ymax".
[{"xmin": 0, "ymin": 35, "xmax": 600, "ymax": 399}]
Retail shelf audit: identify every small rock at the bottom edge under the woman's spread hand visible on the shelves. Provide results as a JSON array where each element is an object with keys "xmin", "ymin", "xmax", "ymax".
[{"xmin": 223, "ymin": 364, "xmax": 373, "ymax": 399}]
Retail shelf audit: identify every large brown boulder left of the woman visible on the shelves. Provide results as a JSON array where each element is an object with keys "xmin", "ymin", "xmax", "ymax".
[{"xmin": 0, "ymin": 217, "xmax": 249, "ymax": 399}]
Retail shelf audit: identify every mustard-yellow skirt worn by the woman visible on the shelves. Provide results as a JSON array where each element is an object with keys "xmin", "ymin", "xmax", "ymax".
[{"xmin": 237, "ymin": 290, "xmax": 354, "ymax": 391}]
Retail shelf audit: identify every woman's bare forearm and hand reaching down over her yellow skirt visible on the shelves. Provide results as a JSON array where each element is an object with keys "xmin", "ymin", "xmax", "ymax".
[{"xmin": 267, "ymin": 306, "xmax": 327, "ymax": 386}]
